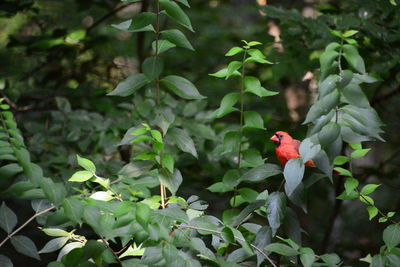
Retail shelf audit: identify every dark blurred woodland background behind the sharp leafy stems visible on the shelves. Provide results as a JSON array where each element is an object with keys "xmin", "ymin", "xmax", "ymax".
[{"xmin": 0, "ymin": 0, "xmax": 400, "ymax": 266}]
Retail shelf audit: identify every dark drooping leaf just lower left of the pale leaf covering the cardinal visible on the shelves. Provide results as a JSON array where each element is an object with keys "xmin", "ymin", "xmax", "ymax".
[{"xmin": 267, "ymin": 192, "xmax": 286, "ymax": 236}]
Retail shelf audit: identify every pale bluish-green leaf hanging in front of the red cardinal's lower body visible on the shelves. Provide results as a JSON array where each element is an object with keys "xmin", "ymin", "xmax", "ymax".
[{"xmin": 283, "ymin": 158, "xmax": 305, "ymax": 196}]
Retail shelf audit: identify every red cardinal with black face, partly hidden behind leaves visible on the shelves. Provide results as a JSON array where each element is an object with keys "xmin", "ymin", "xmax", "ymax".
[{"xmin": 270, "ymin": 131, "xmax": 315, "ymax": 167}]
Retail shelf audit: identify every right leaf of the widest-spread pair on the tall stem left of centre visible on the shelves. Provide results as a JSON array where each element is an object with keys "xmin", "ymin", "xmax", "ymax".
[{"xmin": 160, "ymin": 75, "xmax": 205, "ymax": 99}]
